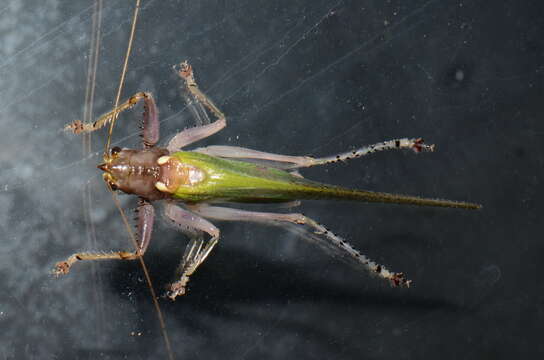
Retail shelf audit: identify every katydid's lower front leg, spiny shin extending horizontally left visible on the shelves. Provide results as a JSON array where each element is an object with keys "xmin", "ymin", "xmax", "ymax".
[{"xmin": 53, "ymin": 201, "xmax": 155, "ymax": 275}]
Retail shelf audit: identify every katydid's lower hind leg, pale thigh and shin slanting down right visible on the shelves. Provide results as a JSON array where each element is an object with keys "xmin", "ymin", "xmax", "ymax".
[{"xmin": 189, "ymin": 205, "xmax": 411, "ymax": 287}]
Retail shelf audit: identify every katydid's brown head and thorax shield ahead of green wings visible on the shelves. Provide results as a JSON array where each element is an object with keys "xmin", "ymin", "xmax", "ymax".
[{"xmin": 98, "ymin": 147, "xmax": 168, "ymax": 200}]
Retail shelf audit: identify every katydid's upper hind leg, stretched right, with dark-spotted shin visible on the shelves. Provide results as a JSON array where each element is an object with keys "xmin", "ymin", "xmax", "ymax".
[{"xmin": 194, "ymin": 138, "xmax": 434, "ymax": 169}]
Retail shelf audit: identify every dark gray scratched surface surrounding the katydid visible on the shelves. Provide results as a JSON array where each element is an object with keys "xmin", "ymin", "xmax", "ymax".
[{"xmin": 0, "ymin": 0, "xmax": 544, "ymax": 359}]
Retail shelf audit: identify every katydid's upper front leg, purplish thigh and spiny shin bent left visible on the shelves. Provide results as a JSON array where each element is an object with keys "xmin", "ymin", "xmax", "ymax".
[{"xmin": 64, "ymin": 92, "xmax": 159, "ymax": 148}]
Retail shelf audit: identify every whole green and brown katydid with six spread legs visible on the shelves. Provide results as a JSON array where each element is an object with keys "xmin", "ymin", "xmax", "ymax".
[{"xmin": 54, "ymin": 62, "xmax": 481, "ymax": 300}]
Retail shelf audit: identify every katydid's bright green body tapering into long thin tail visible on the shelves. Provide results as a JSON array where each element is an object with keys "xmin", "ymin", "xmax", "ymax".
[{"xmin": 170, "ymin": 151, "xmax": 481, "ymax": 209}]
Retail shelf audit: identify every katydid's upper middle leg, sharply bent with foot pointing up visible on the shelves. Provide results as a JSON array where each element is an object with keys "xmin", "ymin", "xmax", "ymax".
[{"xmin": 167, "ymin": 61, "xmax": 227, "ymax": 152}]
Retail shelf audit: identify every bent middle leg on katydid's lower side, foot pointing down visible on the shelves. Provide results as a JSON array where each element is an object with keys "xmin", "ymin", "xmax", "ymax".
[{"xmin": 165, "ymin": 203, "xmax": 219, "ymax": 300}]
